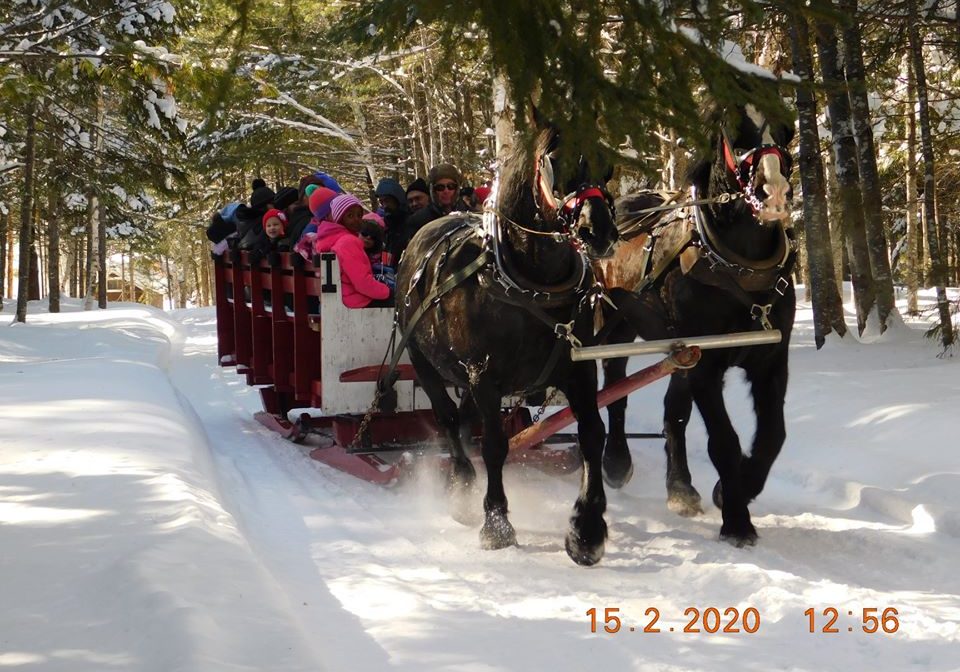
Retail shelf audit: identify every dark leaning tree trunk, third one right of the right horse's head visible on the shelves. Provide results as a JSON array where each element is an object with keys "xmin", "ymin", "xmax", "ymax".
[{"xmin": 840, "ymin": 0, "xmax": 896, "ymax": 333}]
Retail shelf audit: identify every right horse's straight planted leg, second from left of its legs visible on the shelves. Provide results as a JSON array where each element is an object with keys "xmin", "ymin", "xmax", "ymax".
[{"xmin": 663, "ymin": 373, "xmax": 703, "ymax": 518}]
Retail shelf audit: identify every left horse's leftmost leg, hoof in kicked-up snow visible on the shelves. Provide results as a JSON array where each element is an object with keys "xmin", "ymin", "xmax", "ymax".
[{"xmin": 407, "ymin": 344, "xmax": 477, "ymax": 525}]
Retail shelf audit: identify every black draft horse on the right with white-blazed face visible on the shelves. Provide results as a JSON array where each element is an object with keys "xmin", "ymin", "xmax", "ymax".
[{"xmin": 598, "ymin": 105, "xmax": 796, "ymax": 546}]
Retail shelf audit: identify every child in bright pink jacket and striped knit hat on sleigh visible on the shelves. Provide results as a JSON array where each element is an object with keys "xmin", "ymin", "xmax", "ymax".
[{"xmin": 314, "ymin": 194, "xmax": 393, "ymax": 308}]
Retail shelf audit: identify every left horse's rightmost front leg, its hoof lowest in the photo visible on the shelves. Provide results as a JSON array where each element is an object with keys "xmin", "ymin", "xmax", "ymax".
[{"xmin": 564, "ymin": 362, "xmax": 607, "ymax": 566}]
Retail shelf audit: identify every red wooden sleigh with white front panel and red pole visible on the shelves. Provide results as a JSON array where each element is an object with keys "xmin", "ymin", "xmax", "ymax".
[{"xmin": 214, "ymin": 250, "xmax": 772, "ymax": 485}]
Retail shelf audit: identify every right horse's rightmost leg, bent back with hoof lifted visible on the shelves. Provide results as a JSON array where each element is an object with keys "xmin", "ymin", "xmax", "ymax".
[{"xmin": 740, "ymin": 348, "xmax": 787, "ymax": 501}]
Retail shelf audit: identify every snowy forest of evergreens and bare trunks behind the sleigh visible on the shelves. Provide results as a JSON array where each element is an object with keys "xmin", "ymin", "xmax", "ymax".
[{"xmin": 0, "ymin": 0, "xmax": 960, "ymax": 351}]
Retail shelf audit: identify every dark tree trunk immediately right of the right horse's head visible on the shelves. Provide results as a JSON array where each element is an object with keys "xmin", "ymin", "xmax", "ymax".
[{"xmin": 790, "ymin": 13, "xmax": 847, "ymax": 349}]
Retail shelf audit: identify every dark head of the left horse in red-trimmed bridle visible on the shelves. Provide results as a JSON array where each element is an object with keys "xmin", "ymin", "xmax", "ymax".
[{"xmin": 534, "ymin": 128, "xmax": 619, "ymax": 259}]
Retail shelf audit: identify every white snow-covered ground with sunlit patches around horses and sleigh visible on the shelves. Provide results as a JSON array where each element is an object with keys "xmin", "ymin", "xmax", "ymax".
[{"xmin": 0, "ymin": 290, "xmax": 960, "ymax": 672}]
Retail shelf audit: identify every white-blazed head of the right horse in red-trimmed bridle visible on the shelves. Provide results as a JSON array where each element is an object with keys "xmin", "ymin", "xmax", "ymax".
[{"xmin": 714, "ymin": 104, "xmax": 793, "ymax": 225}]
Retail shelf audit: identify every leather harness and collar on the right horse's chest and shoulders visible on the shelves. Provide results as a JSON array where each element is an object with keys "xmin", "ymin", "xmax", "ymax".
[{"xmin": 627, "ymin": 188, "xmax": 797, "ymax": 329}]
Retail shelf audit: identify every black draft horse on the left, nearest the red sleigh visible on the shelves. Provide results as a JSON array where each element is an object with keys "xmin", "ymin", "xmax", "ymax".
[{"xmin": 397, "ymin": 130, "xmax": 618, "ymax": 565}]
